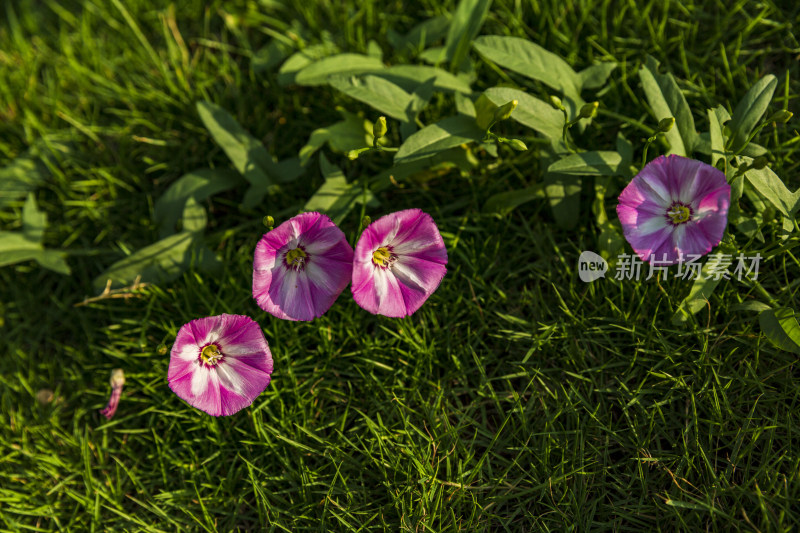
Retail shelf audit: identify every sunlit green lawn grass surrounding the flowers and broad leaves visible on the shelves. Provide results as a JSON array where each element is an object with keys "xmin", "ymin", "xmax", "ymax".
[{"xmin": 0, "ymin": 0, "xmax": 800, "ymax": 532}]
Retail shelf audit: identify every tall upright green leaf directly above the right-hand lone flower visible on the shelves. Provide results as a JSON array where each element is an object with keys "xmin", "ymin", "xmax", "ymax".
[{"xmin": 639, "ymin": 56, "xmax": 697, "ymax": 157}]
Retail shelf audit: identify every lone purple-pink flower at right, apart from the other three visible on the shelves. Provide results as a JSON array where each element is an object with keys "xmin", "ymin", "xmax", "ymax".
[{"xmin": 617, "ymin": 155, "xmax": 731, "ymax": 265}]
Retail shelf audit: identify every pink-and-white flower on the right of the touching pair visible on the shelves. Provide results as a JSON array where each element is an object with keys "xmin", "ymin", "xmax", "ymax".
[{"xmin": 351, "ymin": 209, "xmax": 447, "ymax": 317}]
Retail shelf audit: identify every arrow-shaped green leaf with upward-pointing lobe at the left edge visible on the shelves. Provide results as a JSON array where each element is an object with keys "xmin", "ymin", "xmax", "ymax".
[{"xmin": 0, "ymin": 193, "xmax": 70, "ymax": 274}]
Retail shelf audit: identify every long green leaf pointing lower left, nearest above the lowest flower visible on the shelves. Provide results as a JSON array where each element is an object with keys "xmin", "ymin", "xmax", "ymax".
[{"xmin": 94, "ymin": 231, "xmax": 200, "ymax": 291}]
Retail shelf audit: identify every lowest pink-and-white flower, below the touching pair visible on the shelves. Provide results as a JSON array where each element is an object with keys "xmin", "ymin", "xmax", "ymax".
[{"xmin": 167, "ymin": 315, "xmax": 272, "ymax": 416}]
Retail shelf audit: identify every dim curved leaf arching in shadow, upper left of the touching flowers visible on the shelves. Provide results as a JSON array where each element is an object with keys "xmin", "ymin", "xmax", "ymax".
[{"xmin": 153, "ymin": 168, "xmax": 241, "ymax": 238}]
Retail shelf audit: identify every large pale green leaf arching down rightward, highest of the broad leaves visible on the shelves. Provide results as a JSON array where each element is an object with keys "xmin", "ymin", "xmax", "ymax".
[{"xmin": 473, "ymin": 35, "xmax": 584, "ymax": 116}]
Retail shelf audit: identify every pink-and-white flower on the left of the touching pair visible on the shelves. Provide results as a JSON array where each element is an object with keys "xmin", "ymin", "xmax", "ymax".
[{"xmin": 253, "ymin": 212, "xmax": 353, "ymax": 320}]
